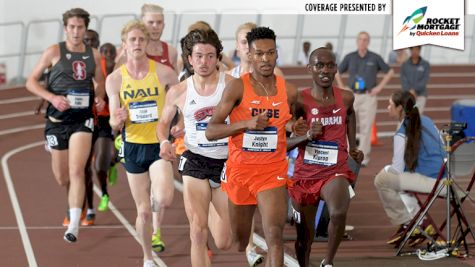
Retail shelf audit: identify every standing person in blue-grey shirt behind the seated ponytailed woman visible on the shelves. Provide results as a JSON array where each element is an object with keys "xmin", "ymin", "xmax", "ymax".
[{"xmin": 400, "ymin": 46, "xmax": 430, "ymax": 114}]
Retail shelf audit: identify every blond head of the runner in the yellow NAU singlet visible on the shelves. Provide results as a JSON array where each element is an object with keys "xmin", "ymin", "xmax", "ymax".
[{"xmin": 121, "ymin": 20, "xmax": 150, "ymax": 58}]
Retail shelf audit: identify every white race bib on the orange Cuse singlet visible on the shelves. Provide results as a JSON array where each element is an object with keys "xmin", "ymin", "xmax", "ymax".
[{"xmin": 242, "ymin": 127, "xmax": 278, "ymax": 152}]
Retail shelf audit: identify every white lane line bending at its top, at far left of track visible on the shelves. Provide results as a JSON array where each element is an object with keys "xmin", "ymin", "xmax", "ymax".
[{"xmin": 2, "ymin": 141, "xmax": 45, "ymax": 267}]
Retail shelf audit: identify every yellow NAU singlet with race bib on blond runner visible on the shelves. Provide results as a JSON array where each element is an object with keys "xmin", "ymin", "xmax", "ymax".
[{"xmin": 119, "ymin": 60, "xmax": 165, "ymax": 144}]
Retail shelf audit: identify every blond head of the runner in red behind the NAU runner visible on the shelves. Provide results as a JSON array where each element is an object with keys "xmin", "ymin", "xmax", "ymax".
[{"xmin": 140, "ymin": 4, "xmax": 165, "ymax": 41}]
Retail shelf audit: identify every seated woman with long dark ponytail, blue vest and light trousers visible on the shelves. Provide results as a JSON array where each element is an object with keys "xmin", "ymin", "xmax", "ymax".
[{"xmin": 374, "ymin": 91, "xmax": 445, "ymax": 248}]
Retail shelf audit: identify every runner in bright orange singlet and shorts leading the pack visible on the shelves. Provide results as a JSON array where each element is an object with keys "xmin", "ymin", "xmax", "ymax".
[{"xmin": 206, "ymin": 27, "xmax": 297, "ymax": 266}]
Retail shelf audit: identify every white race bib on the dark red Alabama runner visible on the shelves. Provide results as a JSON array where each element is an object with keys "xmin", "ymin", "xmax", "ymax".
[{"xmin": 303, "ymin": 141, "xmax": 338, "ymax": 166}]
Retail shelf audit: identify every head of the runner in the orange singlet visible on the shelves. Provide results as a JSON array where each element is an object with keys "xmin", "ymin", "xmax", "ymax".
[{"xmin": 246, "ymin": 27, "xmax": 278, "ymax": 76}]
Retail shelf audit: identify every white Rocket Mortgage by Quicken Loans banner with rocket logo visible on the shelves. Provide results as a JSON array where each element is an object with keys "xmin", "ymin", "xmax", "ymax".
[{"xmin": 393, "ymin": 1, "xmax": 464, "ymax": 50}]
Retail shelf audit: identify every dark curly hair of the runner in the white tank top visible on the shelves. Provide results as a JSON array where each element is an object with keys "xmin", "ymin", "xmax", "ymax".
[{"xmin": 182, "ymin": 29, "xmax": 223, "ymax": 60}]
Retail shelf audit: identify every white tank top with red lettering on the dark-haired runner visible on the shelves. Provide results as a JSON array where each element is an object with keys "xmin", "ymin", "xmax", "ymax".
[{"xmin": 183, "ymin": 72, "xmax": 228, "ymax": 159}]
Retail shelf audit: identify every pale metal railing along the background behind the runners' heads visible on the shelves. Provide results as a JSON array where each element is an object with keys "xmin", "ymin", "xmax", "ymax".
[{"xmin": 0, "ymin": 12, "xmax": 475, "ymax": 86}]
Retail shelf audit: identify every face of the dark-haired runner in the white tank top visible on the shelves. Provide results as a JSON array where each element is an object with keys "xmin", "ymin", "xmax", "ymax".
[{"xmin": 188, "ymin": 43, "xmax": 218, "ymax": 77}]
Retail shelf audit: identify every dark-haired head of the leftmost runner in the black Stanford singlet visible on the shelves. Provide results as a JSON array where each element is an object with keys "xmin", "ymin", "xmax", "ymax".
[{"xmin": 63, "ymin": 8, "xmax": 89, "ymax": 46}]
